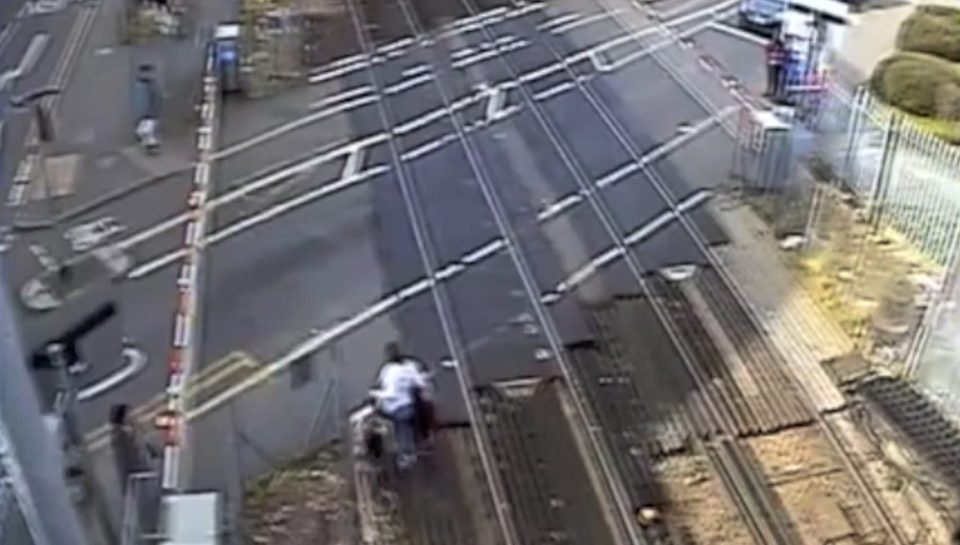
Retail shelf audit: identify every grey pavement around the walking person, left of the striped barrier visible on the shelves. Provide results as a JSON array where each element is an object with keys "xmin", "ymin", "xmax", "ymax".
[{"xmin": 11, "ymin": 0, "xmax": 230, "ymax": 232}]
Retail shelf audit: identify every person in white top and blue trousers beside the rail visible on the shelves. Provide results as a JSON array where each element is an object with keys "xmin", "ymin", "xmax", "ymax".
[{"xmin": 371, "ymin": 343, "xmax": 428, "ymax": 469}]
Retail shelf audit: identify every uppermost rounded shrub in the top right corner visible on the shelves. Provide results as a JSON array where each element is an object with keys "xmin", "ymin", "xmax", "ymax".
[{"xmin": 897, "ymin": 6, "xmax": 960, "ymax": 62}]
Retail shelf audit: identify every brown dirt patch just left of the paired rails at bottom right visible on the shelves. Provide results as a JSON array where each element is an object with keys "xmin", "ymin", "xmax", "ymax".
[{"xmin": 655, "ymin": 455, "xmax": 753, "ymax": 545}]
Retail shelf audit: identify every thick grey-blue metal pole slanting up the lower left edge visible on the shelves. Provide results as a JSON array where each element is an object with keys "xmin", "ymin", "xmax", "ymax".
[{"xmin": 0, "ymin": 255, "xmax": 89, "ymax": 545}]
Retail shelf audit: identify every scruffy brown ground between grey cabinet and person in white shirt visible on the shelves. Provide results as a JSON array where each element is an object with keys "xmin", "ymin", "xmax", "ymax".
[{"xmin": 241, "ymin": 445, "xmax": 356, "ymax": 545}]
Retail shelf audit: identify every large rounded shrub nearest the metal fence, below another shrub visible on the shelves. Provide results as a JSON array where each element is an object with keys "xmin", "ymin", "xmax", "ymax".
[{"xmin": 870, "ymin": 53, "xmax": 960, "ymax": 117}]
